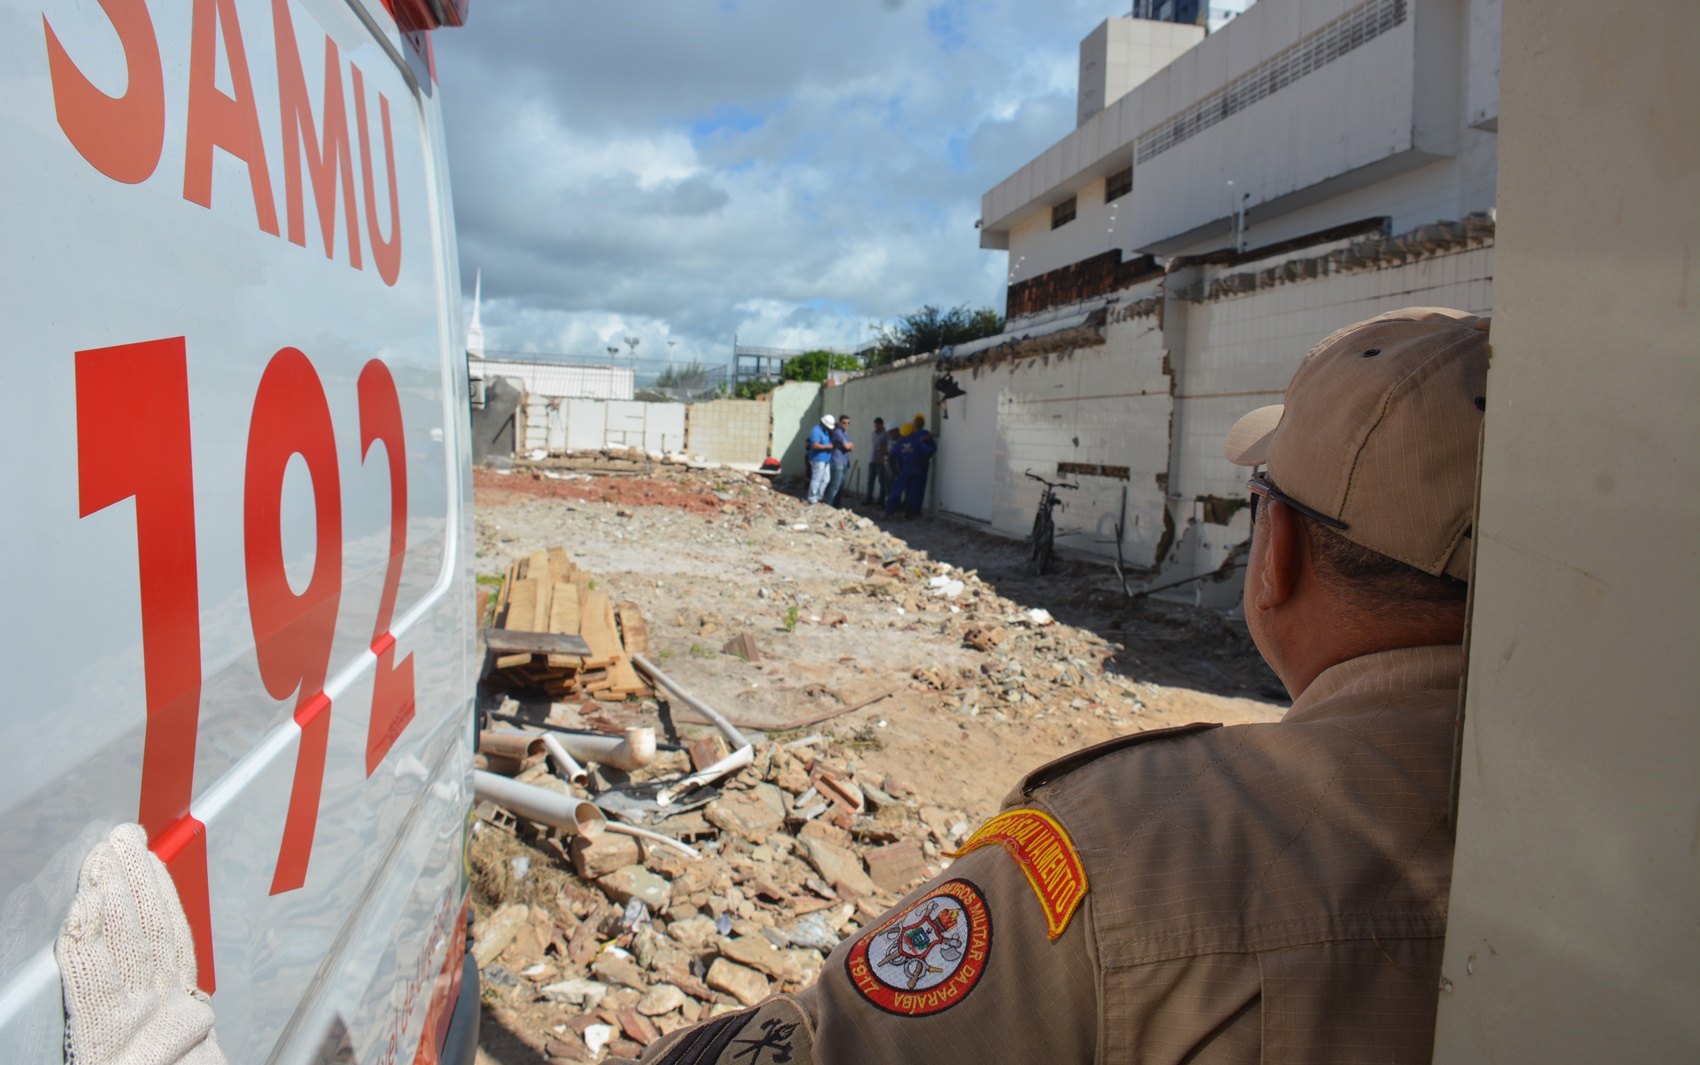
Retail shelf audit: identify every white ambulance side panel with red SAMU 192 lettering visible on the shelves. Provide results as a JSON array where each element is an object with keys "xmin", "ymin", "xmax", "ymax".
[{"xmin": 0, "ymin": 0, "xmax": 478, "ymax": 1065}]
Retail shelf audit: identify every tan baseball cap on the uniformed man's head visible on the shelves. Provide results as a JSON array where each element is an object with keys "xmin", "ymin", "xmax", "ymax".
[{"xmin": 1222, "ymin": 306, "xmax": 1489, "ymax": 580}]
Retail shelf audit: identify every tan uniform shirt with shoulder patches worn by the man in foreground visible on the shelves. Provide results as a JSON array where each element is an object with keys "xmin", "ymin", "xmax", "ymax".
[{"xmin": 644, "ymin": 646, "xmax": 1460, "ymax": 1065}]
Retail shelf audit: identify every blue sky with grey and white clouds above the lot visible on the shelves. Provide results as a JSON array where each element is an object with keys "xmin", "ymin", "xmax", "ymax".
[{"xmin": 435, "ymin": 0, "xmax": 1156, "ymax": 362}]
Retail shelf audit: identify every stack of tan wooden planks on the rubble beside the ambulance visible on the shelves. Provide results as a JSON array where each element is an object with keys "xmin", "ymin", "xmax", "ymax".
[{"xmin": 490, "ymin": 548, "xmax": 655, "ymax": 699}]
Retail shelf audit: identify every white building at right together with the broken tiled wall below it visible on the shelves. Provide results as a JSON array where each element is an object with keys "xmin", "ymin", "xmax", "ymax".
[{"xmin": 958, "ymin": 0, "xmax": 1499, "ymax": 606}]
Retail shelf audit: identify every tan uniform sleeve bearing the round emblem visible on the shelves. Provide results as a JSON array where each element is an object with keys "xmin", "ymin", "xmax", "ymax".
[{"xmin": 643, "ymin": 846, "xmax": 1098, "ymax": 1065}]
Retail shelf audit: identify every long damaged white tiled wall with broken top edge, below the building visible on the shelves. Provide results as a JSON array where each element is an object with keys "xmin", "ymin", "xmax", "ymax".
[{"xmin": 825, "ymin": 218, "xmax": 1493, "ymax": 609}]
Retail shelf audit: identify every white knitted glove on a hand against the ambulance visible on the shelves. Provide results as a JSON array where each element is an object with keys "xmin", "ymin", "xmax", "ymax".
[{"xmin": 53, "ymin": 825, "xmax": 224, "ymax": 1065}]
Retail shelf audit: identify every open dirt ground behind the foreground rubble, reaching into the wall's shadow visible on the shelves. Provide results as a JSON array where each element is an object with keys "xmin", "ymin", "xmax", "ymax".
[{"xmin": 474, "ymin": 458, "xmax": 1285, "ymax": 1065}]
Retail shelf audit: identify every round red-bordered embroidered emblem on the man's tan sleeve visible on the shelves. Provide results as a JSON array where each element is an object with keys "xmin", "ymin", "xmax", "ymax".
[{"xmin": 845, "ymin": 880, "xmax": 991, "ymax": 1017}]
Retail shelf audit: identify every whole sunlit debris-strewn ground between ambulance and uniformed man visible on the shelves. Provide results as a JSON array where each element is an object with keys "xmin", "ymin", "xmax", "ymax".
[{"xmin": 469, "ymin": 459, "xmax": 1285, "ymax": 1062}]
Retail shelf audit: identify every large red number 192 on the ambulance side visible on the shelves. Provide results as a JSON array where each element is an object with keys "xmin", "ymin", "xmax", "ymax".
[{"xmin": 77, "ymin": 337, "xmax": 413, "ymax": 992}]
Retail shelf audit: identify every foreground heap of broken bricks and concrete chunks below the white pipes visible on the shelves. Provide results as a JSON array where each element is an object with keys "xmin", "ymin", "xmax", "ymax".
[{"xmin": 471, "ymin": 714, "xmax": 971, "ymax": 1062}]
